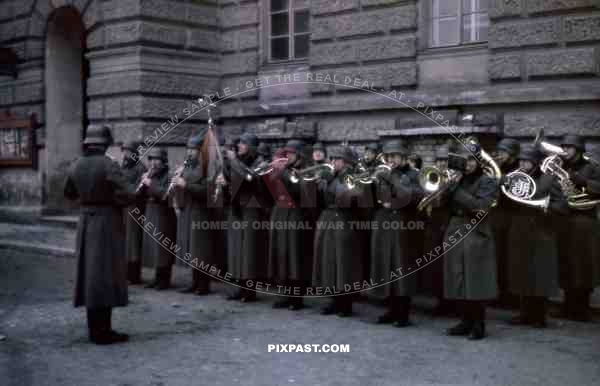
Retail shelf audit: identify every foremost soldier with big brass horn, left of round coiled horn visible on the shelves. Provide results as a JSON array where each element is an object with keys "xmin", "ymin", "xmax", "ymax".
[{"xmin": 444, "ymin": 145, "xmax": 499, "ymax": 340}]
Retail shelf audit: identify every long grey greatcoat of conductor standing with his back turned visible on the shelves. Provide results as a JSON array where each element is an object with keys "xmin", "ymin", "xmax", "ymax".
[{"xmin": 64, "ymin": 152, "xmax": 135, "ymax": 308}]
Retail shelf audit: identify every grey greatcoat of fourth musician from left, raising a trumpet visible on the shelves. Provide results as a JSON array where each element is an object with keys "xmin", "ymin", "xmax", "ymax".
[{"xmin": 226, "ymin": 155, "xmax": 273, "ymax": 284}]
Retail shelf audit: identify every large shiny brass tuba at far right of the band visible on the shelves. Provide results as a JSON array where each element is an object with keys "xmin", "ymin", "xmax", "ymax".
[{"xmin": 534, "ymin": 129, "xmax": 600, "ymax": 210}]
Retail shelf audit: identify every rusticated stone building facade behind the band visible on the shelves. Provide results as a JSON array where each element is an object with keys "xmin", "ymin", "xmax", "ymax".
[{"xmin": 0, "ymin": 0, "xmax": 600, "ymax": 216}]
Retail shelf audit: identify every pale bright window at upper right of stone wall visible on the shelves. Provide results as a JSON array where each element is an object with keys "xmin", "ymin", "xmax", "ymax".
[{"xmin": 430, "ymin": 0, "xmax": 489, "ymax": 47}]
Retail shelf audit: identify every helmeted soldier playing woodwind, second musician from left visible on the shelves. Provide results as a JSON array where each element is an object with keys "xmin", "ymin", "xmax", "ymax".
[{"xmin": 141, "ymin": 147, "xmax": 177, "ymax": 290}]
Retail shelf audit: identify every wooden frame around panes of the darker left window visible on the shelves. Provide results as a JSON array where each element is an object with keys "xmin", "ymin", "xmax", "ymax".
[{"xmin": 265, "ymin": 0, "xmax": 311, "ymax": 64}]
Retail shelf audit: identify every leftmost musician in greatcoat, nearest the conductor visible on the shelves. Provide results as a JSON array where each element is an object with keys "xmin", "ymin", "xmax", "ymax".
[{"xmin": 121, "ymin": 141, "xmax": 146, "ymax": 284}]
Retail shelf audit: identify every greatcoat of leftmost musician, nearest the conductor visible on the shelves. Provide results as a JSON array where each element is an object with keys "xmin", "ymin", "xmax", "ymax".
[{"xmin": 121, "ymin": 162, "xmax": 146, "ymax": 262}]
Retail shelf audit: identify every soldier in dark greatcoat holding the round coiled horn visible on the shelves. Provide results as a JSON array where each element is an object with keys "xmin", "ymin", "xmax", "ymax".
[{"xmin": 506, "ymin": 147, "xmax": 564, "ymax": 328}]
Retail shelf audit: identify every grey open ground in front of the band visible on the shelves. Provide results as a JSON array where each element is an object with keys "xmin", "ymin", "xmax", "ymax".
[{"xmin": 0, "ymin": 250, "xmax": 600, "ymax": 386}]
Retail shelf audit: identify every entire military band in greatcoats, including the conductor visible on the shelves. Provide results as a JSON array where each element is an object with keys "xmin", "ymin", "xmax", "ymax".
[{"xmin": 65, "ymin": 123, "xmax": 600, "ymax": 343}]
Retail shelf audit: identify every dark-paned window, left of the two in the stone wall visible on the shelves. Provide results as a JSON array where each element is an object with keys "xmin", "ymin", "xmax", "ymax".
[{"xmin": 269, "ymin": 0, "xmax": 310, "ymax": 61}]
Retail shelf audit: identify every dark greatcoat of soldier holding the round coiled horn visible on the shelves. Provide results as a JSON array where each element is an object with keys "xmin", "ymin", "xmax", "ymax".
[{"xmin": 506, "ymin": 171, "xmax": 563, "ymax": 297}]
